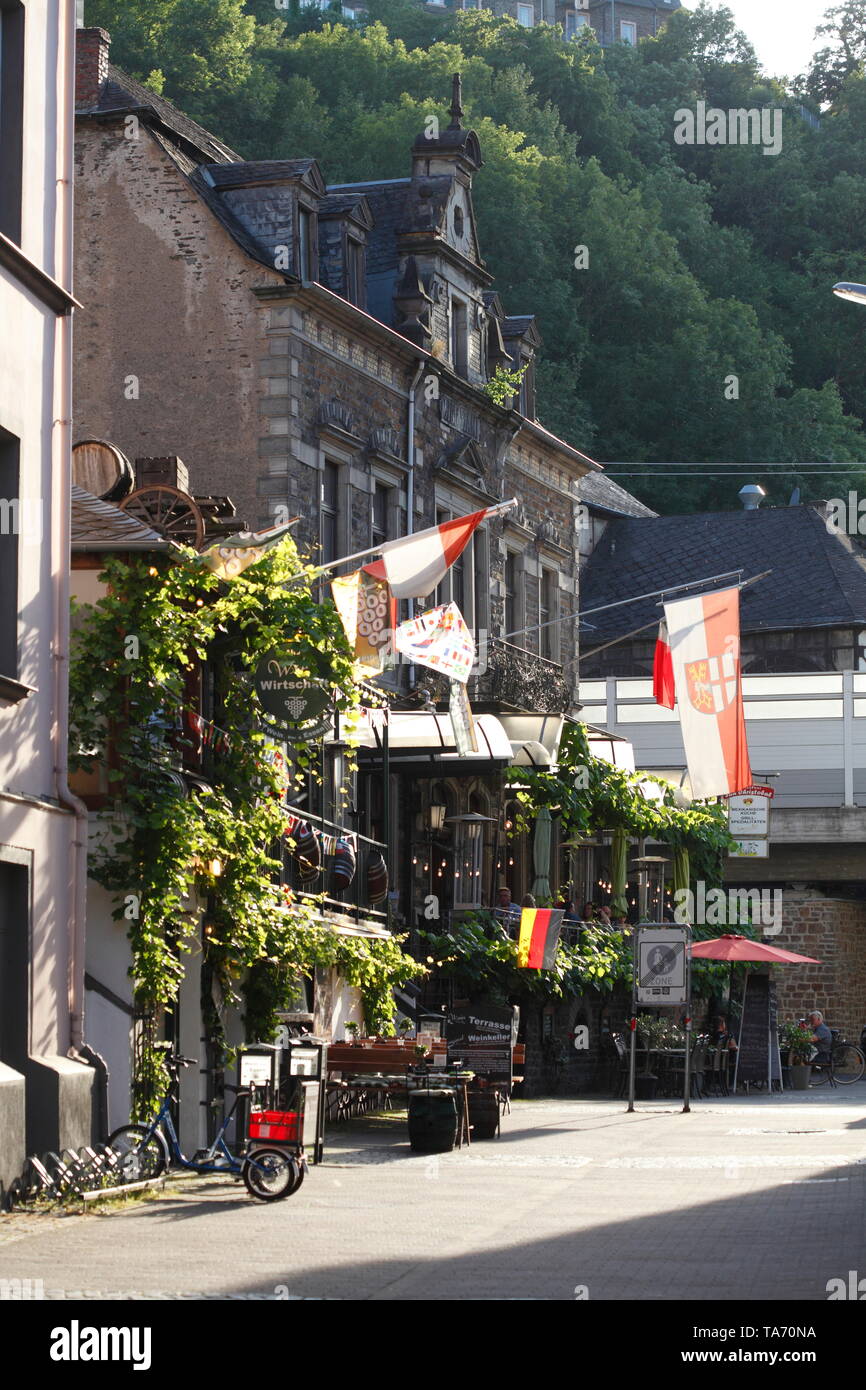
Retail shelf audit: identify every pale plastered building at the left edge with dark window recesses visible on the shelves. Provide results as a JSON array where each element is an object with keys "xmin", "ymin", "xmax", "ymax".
[{"xmin": 0, "ymin": 0, "xmax": 95, "ymax": 1201}]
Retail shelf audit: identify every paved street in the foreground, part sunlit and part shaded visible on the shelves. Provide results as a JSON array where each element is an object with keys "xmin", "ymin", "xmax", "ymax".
[{"xmin": 0, "ymin": 1083, "xmax": 866, "ymax": 1302}]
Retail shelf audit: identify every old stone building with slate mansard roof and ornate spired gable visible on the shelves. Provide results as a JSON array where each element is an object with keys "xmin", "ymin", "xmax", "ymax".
[{"xmin": 75, "ymin": 31, "xmax": 598, "ymax": 1073}]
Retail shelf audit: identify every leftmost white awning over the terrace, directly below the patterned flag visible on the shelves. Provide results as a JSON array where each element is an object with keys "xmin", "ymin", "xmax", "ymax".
[{"xmin": 352, "ymin": 712, "xmax": 513, "ymax": 776}]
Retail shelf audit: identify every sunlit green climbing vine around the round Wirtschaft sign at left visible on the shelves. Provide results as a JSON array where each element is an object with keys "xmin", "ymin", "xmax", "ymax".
[{"xmin": 70, "ymin": 539, "xmax": 418, "ymax": 1104}]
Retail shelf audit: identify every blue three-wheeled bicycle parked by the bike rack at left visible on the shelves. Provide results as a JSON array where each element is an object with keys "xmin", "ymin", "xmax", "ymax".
[{"xmin": 108, "ymin": 1052, "xmax": 307, "ymax": 1202}]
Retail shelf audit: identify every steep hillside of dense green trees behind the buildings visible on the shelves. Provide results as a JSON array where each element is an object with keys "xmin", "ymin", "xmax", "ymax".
[{"xmin": 86, "ymin": 0, "xmax": 866, "ymax": 512}]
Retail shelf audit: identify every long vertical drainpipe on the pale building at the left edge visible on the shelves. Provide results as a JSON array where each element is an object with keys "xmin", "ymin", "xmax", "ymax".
[{"xmin": 51, "ymin": 8, "xmax": 88, "ymax": 1052}]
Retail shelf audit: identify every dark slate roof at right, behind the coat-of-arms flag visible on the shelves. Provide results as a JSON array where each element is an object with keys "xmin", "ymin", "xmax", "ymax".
[{"xmin": 581, "ymin": 505, "xmax": 866, "ymax": 646}]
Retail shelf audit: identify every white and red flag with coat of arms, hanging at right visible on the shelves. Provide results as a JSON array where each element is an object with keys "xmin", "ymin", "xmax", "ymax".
[{"xmin": 664, "ymin": 588, "xmax": 752, "ymax": 799}]
